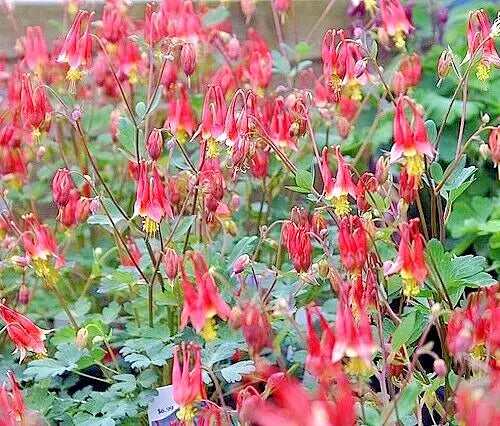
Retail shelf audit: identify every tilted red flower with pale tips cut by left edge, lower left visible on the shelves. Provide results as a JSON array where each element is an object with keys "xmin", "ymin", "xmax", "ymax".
[{"xmin": 0, "ymin": 303, "xmax": 50, "ymax": 362}]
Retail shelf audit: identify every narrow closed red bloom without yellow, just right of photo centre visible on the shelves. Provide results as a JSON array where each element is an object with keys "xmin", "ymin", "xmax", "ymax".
[{"xmin": 282, "ymin": 207, "xmax": 312, "ymax": 273}]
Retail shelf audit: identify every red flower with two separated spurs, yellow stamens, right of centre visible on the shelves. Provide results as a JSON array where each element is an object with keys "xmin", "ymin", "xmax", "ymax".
[{"xmin": 320, "ymin": 145, "xmax": 356, "ymax": 216}]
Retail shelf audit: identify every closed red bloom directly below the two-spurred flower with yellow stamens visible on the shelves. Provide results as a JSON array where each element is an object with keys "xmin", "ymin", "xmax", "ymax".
[{"xmin": 339, "ymin": 215, "xmax": 368, "ymax": 275}]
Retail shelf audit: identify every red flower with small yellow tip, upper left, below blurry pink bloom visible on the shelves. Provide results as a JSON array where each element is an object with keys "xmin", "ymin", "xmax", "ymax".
[{"xmin": 21, "ymin": 74, "xmax": 52, "ymax": 141}]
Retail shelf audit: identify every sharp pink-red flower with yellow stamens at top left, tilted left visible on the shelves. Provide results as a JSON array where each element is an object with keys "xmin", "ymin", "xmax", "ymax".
[{"xmin": 57, "ymin": 10, "xmax": 94, "ymax": 86}]
